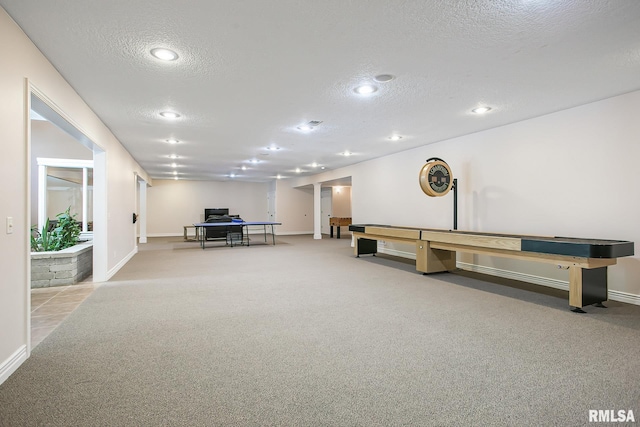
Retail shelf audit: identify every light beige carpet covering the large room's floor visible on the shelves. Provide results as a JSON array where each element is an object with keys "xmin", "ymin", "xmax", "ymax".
[{"xmin": 0, "ymin": 236, "xmax": 640, "ymax": 426}]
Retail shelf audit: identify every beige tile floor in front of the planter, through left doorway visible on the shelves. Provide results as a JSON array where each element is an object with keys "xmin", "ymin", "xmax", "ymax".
[{"xmin": 31, "ymin": 279, "xmax": 100, "ymax": 350}]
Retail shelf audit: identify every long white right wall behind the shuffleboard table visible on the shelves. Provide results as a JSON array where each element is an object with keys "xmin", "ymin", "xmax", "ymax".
[{"xmin": 293, "ymin": 91, "xmax": 640, "ymax": 302}]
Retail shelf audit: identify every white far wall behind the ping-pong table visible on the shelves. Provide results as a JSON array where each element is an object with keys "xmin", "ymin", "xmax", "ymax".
[{"xmin": 147, "ymin": 180, "xmax": 268, "ymax": 237}]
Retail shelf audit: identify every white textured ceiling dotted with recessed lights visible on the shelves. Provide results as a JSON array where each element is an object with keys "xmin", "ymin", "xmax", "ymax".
[{"xmin": 0, "ymin": 0, "xmax": 640, "ymax": 181}]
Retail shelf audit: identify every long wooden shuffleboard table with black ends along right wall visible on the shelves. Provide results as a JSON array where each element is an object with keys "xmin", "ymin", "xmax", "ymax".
[{"xmin": 349, "ymin": 224, "xmax": 634, "ymax": 313}]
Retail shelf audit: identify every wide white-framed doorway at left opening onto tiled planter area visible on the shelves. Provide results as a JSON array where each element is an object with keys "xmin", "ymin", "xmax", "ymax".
[{"xmin": 25, "ymin": 88, "xmax": 107, "ymax": 353}]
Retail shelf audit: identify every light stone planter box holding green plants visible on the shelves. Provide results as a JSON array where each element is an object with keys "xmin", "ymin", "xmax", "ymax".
[{"xmin": 31, "ymin": 242, "xmax": 93, "ymax": 288}]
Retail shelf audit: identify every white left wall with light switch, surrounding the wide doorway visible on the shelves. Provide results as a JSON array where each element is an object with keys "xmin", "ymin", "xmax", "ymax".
[{"xmin": 0, "ymin": 8, "xmax": 150, "ymax": 382}]
